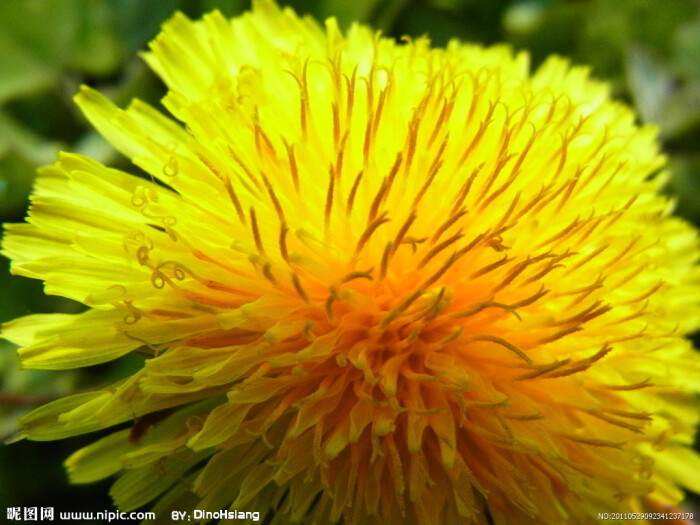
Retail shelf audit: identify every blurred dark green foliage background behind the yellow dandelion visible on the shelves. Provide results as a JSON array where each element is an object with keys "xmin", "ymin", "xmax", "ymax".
[{"xmin": 0, "ymin": 0, "xmax": 700, "ymax": 523}]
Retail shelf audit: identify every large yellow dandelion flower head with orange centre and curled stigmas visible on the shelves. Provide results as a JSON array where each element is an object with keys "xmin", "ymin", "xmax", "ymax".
[{"xmin": 3, "ymin": 0, "xmax": 700, "ymax": 525}]
